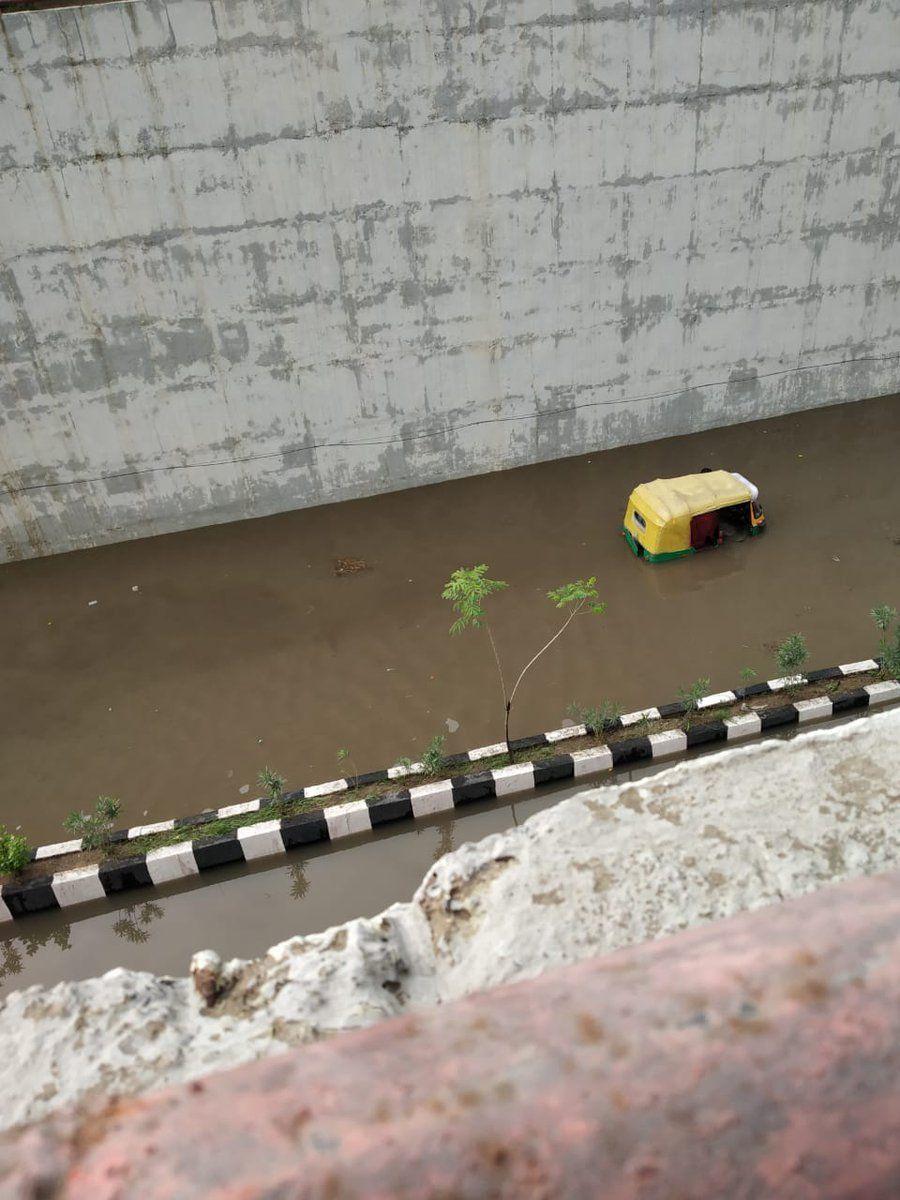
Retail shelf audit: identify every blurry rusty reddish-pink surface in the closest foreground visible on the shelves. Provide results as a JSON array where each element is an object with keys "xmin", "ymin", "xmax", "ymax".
[{"xmin": 0, "ymin": 875, "xmax": 900, "ymax": 1200}]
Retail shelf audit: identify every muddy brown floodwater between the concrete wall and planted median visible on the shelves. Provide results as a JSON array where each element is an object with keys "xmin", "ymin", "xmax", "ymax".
[{"xmin": 0, "ymin": 397, "xmax": 900, "ymax": 842}]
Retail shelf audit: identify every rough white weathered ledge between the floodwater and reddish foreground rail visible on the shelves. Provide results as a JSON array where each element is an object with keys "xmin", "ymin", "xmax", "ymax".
[{"xmin": 0, "ymin": 712, "xmax": 900, "ymax": 1126}]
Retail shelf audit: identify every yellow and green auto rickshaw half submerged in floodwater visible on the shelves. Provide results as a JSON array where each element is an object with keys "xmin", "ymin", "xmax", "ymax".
[{"xmin": 622, "ymin": 468, "xmax": 766, "ymax": 563}]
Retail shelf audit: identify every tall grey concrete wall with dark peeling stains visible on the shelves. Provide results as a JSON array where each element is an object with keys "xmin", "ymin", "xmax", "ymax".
[{"xmin": 0, "ymin": 0, "xmax": 900, "ymax": 558}]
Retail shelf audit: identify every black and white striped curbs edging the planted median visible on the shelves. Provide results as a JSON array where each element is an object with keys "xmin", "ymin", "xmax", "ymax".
[{"xmin": 0, "ymin": 659, "xmax": 900, "ymax": 922}]
